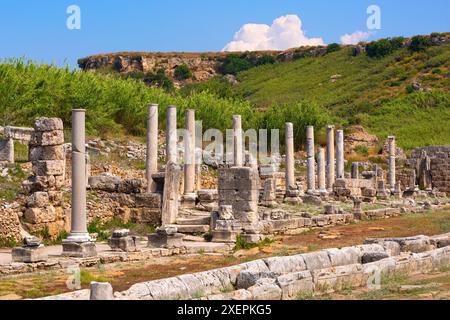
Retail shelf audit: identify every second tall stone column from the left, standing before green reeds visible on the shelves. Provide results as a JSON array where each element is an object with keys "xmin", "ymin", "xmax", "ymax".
[{"xmin": 145, "ymin": 104, "xmax": 158, "ymax": 193}]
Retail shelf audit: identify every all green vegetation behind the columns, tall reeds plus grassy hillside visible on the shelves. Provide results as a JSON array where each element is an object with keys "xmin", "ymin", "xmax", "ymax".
[{"xmin": 0, "ymin": 36, "xmax": 450, "ymax": 149}]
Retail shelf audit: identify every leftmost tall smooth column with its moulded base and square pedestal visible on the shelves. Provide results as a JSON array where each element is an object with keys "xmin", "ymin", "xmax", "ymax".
[{"xmin": 63, "ymin": 109, "xmax": 97, "ymax": 257}]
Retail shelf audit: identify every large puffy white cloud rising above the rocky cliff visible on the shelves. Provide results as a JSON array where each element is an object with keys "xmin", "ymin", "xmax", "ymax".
[{"xmin": 222, "ymin": 14, "xmax": 324, "ymax": 51}]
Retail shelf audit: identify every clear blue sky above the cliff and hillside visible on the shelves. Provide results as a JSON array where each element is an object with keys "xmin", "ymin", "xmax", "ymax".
[{"xmin": 0, "ymin": 0, "xmax": 450, "ymax": 67}]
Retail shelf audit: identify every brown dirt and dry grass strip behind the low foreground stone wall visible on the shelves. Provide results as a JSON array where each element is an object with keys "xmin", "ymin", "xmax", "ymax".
[{"xmin": 0, "ymin": 209, "xmax": 450, "ymax": 298}]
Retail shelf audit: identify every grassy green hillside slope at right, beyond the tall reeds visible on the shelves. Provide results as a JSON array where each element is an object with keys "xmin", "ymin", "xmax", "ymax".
[{"xmin": 234, "ymin": 40, "xmax": 450, "ymax": 148}]
